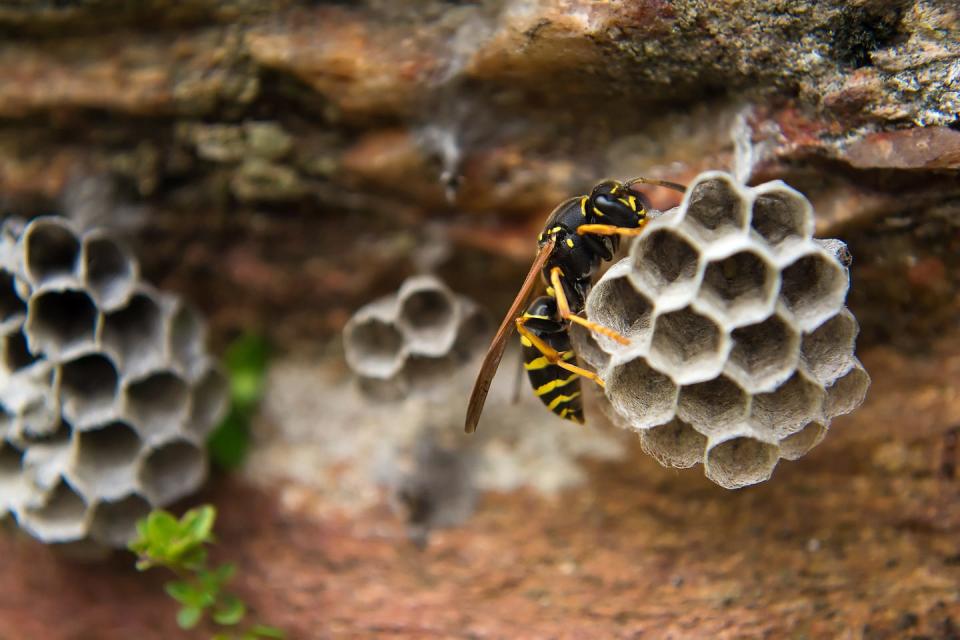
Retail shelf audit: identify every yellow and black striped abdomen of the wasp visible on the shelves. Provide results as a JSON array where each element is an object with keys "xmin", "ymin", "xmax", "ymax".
[{"xmin": 520, "ymin": 332, "xmax": 583, "ymax": 424}]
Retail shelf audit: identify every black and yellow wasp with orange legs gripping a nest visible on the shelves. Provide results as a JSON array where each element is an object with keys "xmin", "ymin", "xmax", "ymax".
[{"xmin": 465, "ymin": 178, "xmax": 686, "ymax": 433}]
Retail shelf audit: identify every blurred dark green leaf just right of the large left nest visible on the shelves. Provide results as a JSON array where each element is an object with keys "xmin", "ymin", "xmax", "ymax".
[{"xmin": 208, "ymin": 333, "xmax": 269, "ymax": 469}]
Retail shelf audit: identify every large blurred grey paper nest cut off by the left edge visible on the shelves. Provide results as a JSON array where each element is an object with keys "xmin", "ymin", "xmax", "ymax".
[{"xmin": 0, "ymin": 217, "xmax": 227, "ymax": 546}]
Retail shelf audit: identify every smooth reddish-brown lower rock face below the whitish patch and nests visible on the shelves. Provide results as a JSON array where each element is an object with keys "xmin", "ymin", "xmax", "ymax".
[{"xmin": 0, "ymin": 339, "xmax": 960, "ymax": 640}]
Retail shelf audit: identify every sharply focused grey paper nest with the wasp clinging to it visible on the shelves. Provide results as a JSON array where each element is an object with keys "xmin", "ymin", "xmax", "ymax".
[{"xmin": 578, "ymin": 172, "xmax": 870, "ymax": 489}]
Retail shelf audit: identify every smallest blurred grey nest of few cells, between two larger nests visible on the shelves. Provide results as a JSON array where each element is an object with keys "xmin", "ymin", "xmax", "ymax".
[{"xmin": 343, "ymin": 275, "xmax": 489, "ymax": 399}]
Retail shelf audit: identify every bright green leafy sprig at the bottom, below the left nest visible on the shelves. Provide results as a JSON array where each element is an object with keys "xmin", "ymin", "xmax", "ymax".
[{"xmin": 130, "ymin": 505, "xmax": 286, "ymax": 640}]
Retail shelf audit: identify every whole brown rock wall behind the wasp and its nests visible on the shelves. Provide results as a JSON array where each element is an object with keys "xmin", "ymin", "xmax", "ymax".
[{"xmin": 0, "ymin": 0, "xmax": 960, "ymax": 639}]
